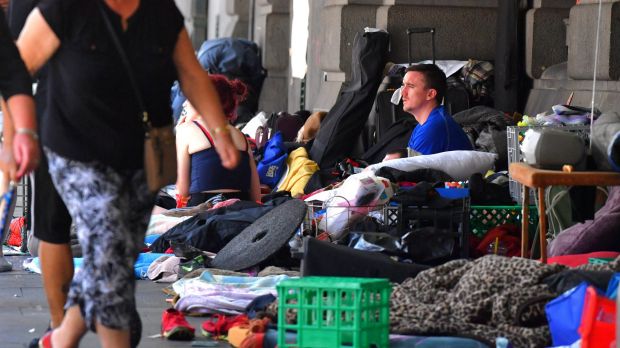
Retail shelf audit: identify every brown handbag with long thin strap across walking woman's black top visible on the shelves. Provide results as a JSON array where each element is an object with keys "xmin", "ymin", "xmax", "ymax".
[{"xmin": 97, "ymin": 1, "xmax": 177, "ymax": 192}]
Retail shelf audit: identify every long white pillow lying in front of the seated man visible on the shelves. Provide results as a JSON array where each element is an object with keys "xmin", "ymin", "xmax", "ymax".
[{"xmin": 367, "ymin": 151, "xmax": 497, "ymax": 181}]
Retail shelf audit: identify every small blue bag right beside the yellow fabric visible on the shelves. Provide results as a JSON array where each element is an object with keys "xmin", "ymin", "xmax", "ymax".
[{"xmin": 256, "ymin": 132, "xmax": 288, "ymax": 188}]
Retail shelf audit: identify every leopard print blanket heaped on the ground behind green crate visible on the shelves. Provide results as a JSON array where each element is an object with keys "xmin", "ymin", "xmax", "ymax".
[{"xmin": 390, "ymin": 255, "xmax": 620, "ymax": 347}]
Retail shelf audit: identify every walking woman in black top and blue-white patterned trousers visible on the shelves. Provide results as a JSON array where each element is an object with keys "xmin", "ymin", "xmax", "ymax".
[{"xmin": 17, "ymin": 0, "xmax": 239, "ymax": 347}]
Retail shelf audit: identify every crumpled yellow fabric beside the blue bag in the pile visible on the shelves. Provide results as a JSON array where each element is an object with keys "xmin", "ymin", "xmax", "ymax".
[{"xmin": 278, "ymin": 147, "xmax": 319, "ymax": 197}]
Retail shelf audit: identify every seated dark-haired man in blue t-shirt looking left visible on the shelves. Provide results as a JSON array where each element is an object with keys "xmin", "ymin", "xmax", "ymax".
[{"xmin": 401, "ymin": 64, "xmax": 473, "ymax": 156}]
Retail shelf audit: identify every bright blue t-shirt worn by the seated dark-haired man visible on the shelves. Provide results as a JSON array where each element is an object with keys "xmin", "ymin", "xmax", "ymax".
[{"xmin": 407, "ymin": 106, "xmax": 473, "ymax": 155}]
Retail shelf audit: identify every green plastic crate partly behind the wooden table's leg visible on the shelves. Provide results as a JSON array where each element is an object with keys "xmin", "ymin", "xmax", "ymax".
[{"xmin": 469, "ymin": 205, "xmax": 538, "ymax": 237}]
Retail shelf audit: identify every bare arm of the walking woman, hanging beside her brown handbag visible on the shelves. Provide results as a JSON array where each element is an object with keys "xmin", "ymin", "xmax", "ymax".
[{"xmin": 173, "ymin": 29, "xmax": 240, "ymax": 169}]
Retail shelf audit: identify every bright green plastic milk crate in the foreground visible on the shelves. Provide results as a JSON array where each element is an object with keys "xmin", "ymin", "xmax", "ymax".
[{"xmin": 277, "ymin": 277, "xmax": 392, "ymax": 348}]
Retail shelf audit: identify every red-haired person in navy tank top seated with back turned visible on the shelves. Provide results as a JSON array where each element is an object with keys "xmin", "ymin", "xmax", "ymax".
[{"xmin": 176, "ymin": 75, "xmax": 260, "ymax": 208}]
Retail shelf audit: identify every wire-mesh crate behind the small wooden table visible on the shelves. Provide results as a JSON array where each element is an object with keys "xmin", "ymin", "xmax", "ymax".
[{"xmin": 506, "ymin": 125, "xmax": 590, "ymax": 205}]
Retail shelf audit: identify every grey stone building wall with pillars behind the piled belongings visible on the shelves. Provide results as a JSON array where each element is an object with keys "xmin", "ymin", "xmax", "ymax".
[{"xmin": 191, "ymin": 0, "xmax": 620, "ymax": 113}]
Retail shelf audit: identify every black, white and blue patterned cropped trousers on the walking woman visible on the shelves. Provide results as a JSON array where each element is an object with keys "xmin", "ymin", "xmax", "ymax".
[{"xmin": 45, "ymin": 148, "xmax": 154, "ymax": 331}]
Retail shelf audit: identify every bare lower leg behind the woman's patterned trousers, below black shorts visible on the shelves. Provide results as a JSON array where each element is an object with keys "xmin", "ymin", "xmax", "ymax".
[{"xmin": 39, "ymin": 241, "xmax": 73, "ymax": 328}]
